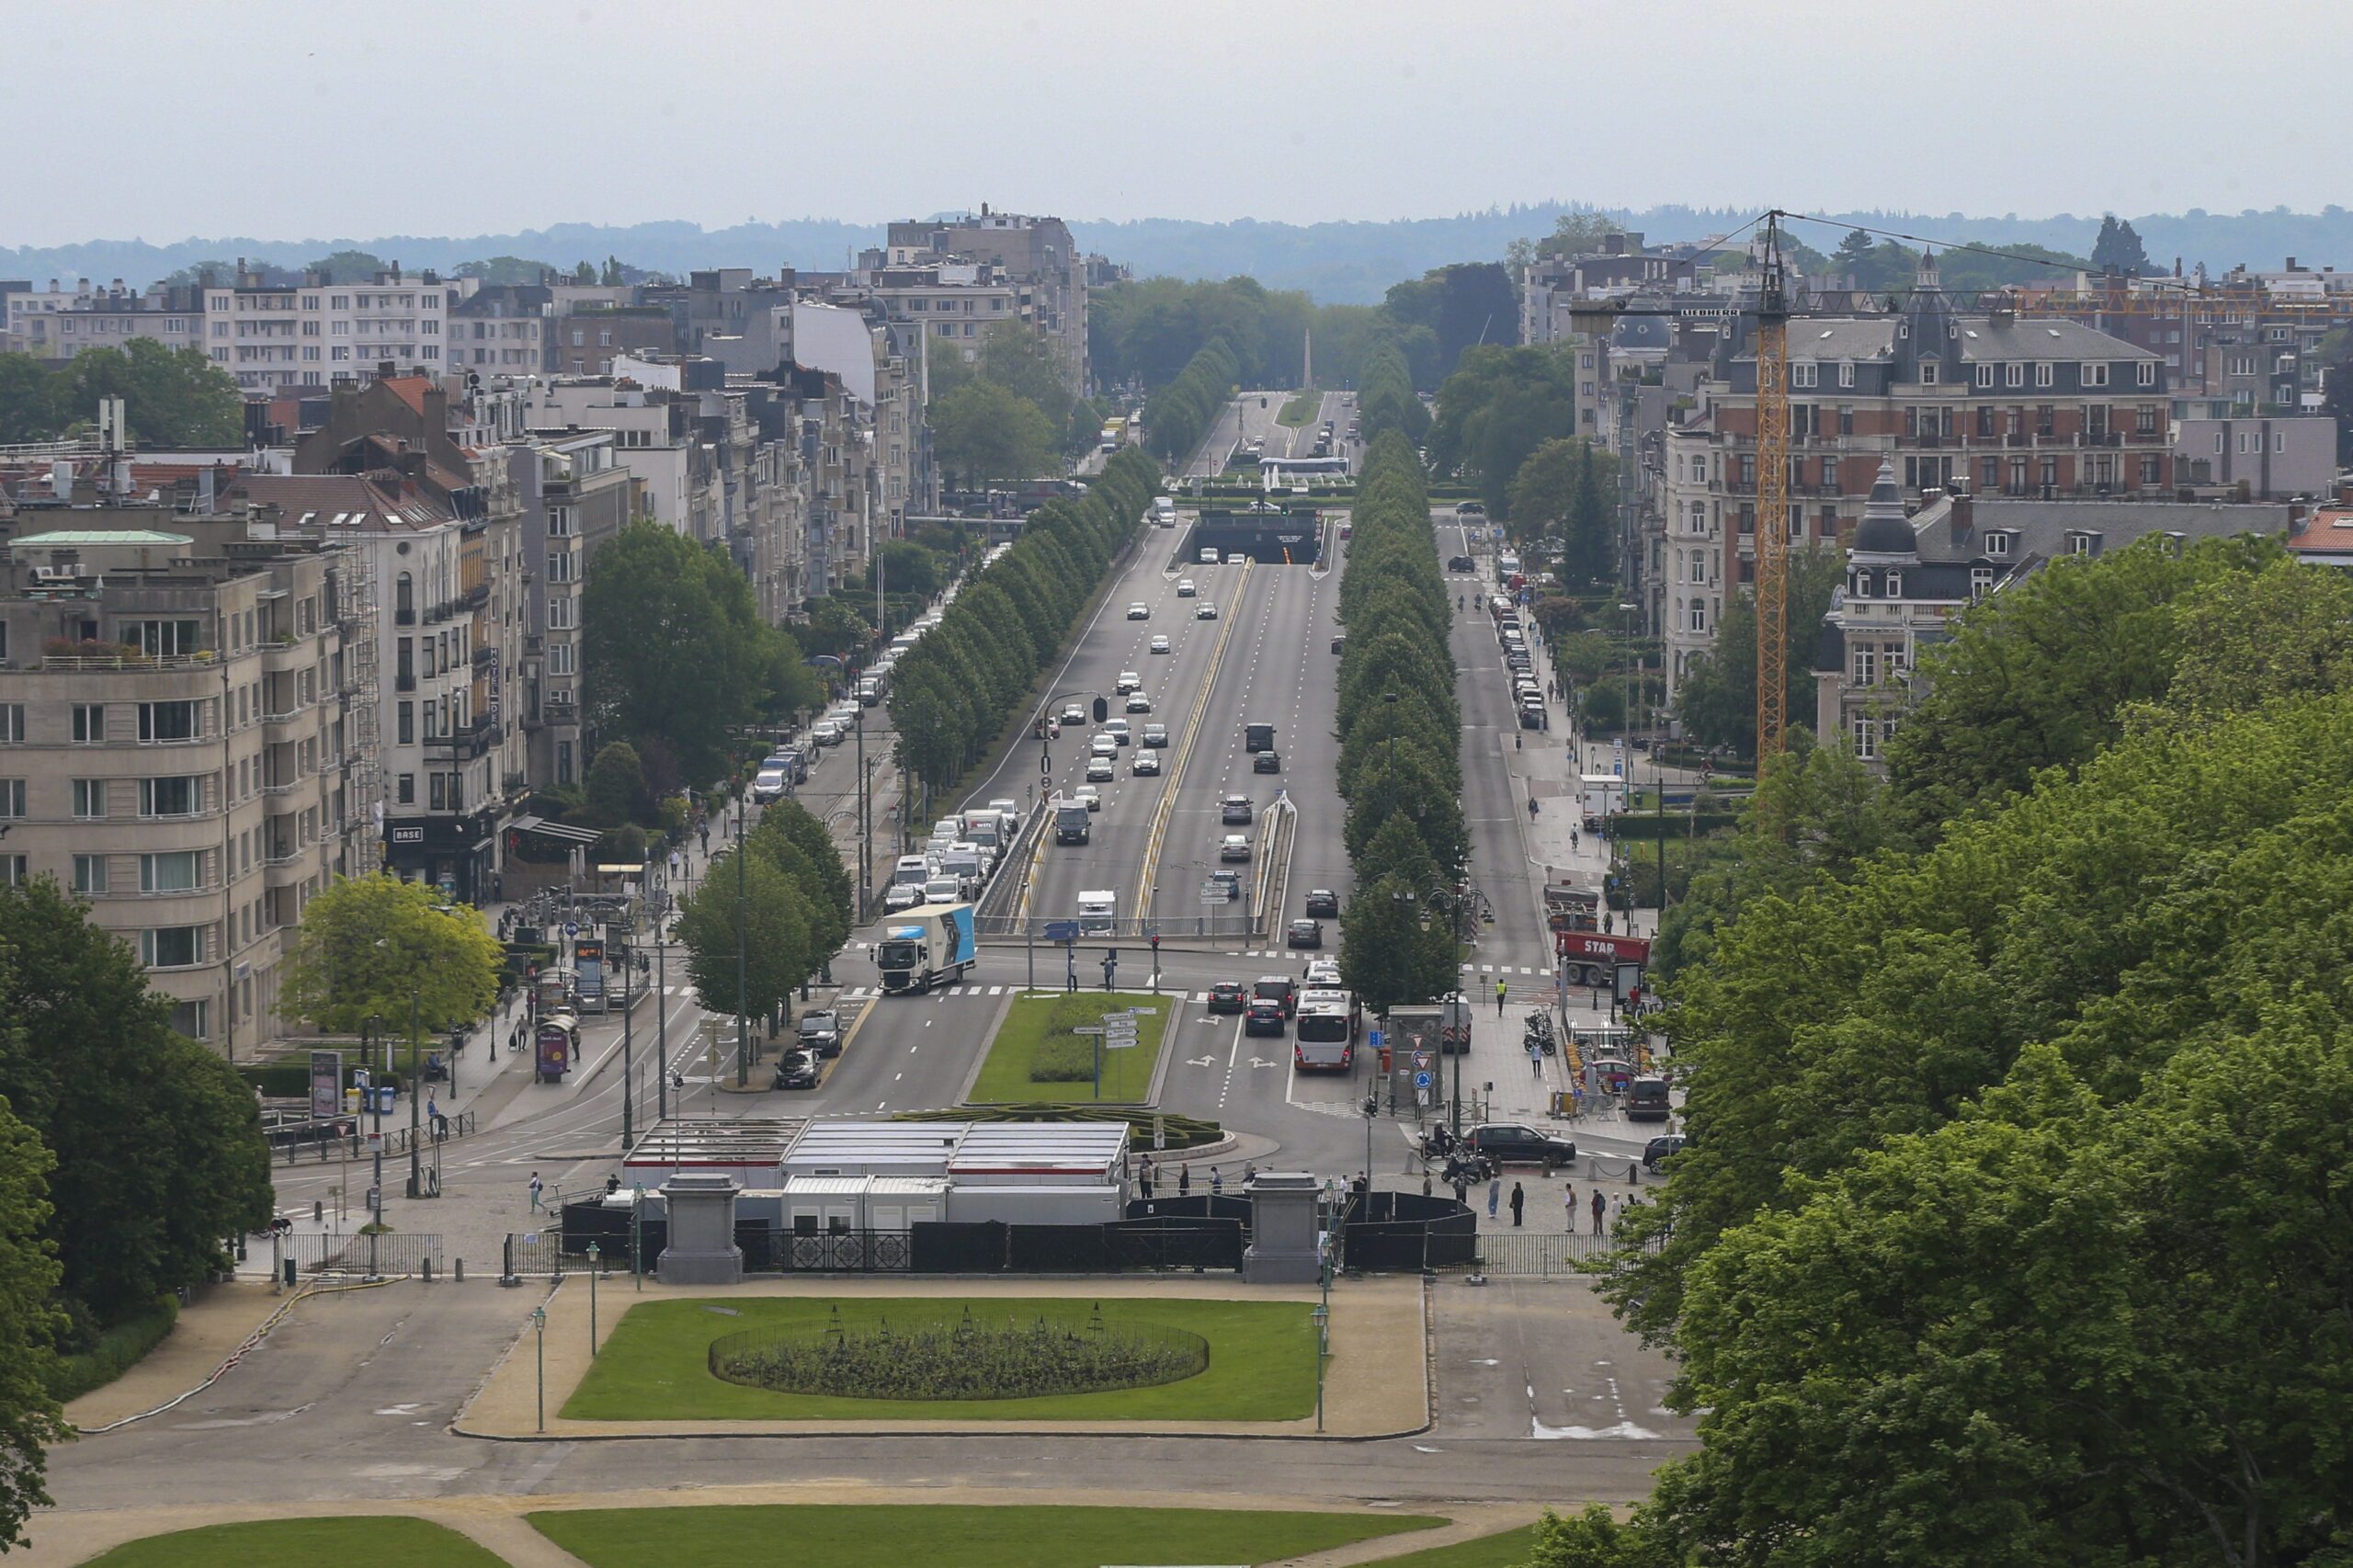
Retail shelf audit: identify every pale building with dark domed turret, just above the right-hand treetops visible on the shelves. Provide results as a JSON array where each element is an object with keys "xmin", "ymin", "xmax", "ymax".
[{"xmin": 1814, "ymin": 457, "xmax": 2308, "ymax": 767}]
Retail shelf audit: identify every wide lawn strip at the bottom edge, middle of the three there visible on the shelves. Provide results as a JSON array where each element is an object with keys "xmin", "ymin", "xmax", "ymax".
[{"xmin": 529, "ymin": 1505, "xmax": 1442, "ymax": 1568}]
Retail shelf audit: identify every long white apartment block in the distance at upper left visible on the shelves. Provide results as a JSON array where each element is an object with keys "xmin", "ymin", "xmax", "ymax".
[{"xmin": 202, "ymin": 261, "xmax": 473, "ymax": 391}]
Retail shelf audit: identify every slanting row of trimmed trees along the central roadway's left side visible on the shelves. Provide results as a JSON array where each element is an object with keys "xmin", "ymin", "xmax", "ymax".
[{"xmin": 890, "ymin": 448, "xmax": 1160, "ymax": 791}]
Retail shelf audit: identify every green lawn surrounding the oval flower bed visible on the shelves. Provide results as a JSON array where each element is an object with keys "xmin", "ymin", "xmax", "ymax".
[{"xmin": 563, "ymin": 1297, "xmax": 1315, "ymax": 1422}]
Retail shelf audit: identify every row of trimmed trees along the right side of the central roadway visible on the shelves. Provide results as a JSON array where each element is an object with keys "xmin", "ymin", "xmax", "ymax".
[{"xmin": 1336, "ymin": 431, "xmax": 1471, "ymax": 1010}]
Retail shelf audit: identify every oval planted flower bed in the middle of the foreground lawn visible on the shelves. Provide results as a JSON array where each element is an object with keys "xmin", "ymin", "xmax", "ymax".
[{"xmin": 710, "ymin": 1309, "xmax": 1210, "ymax": 1399}]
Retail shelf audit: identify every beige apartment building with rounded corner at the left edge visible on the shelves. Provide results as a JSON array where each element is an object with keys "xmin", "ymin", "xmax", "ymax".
[{"xmin": 0, "ymin": 502, "xmax": 374, "ymax": 1057}]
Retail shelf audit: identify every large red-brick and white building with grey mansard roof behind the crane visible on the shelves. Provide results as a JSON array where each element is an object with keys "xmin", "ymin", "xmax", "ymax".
[{"xmin": 1659, "ymin": 259, "xmax": 2174, "ymax": 692}]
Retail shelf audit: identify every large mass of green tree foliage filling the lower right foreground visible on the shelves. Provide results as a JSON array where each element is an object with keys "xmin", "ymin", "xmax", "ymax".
[{"xmin": 1572, "ymin": 527, "xmax": 2353, "ymax": 1568}]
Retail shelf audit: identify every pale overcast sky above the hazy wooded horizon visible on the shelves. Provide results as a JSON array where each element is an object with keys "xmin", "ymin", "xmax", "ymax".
[{"xmin": 0, "ymin": 0, "xmax": 2353, "ymax": 244}]
